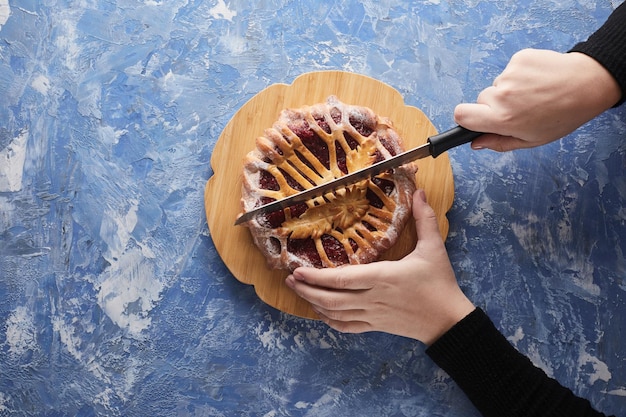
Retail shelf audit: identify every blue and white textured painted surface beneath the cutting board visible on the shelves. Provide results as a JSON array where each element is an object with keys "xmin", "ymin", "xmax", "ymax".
[{"xmin": 0, "ymin": 0, "xmax": 626, "ymax": 417}]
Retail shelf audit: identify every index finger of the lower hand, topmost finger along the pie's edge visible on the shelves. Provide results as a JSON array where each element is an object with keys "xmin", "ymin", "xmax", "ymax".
[{"xmin": 293, "ymin": 263, "xmax": 382, "ymax": 290}]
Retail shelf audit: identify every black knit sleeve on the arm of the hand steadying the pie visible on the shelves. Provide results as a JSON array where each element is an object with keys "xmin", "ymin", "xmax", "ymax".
[{"xmin": 426, "ymin": 308, "xmax": 604, "ymax": 417}]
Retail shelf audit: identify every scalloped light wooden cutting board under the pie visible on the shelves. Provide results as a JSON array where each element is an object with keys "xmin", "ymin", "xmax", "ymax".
[{"xmin": 204, "ymin": 71, "xmax": 454, "ymax": 319}]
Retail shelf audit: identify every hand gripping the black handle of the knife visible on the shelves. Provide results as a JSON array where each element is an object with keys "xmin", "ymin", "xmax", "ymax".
[{"xmin": 454, "ymin": 49, "xmax": 622, "ymax": 152}]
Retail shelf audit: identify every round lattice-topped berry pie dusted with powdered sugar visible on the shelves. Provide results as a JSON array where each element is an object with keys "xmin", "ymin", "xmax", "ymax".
[{"xmin": 241, "ymin": 96, "xmax": 417, "ymax": 271}]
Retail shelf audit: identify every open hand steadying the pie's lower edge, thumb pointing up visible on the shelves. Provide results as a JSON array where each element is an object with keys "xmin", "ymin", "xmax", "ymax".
[{"xmin": 286, "ymin": 190, "xmax": 474, "ymax": 345}]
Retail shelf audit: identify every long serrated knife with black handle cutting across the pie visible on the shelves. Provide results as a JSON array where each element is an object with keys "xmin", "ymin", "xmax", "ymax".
[{"xmin": 235, "ymin": 126, "xmax": 482, "ymax": 225}]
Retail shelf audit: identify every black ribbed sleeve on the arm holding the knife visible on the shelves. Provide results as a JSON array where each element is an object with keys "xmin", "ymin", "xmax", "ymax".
[{"xmin": 570, "ymin": 3, "xmax": 626, "ymax": 105}]
